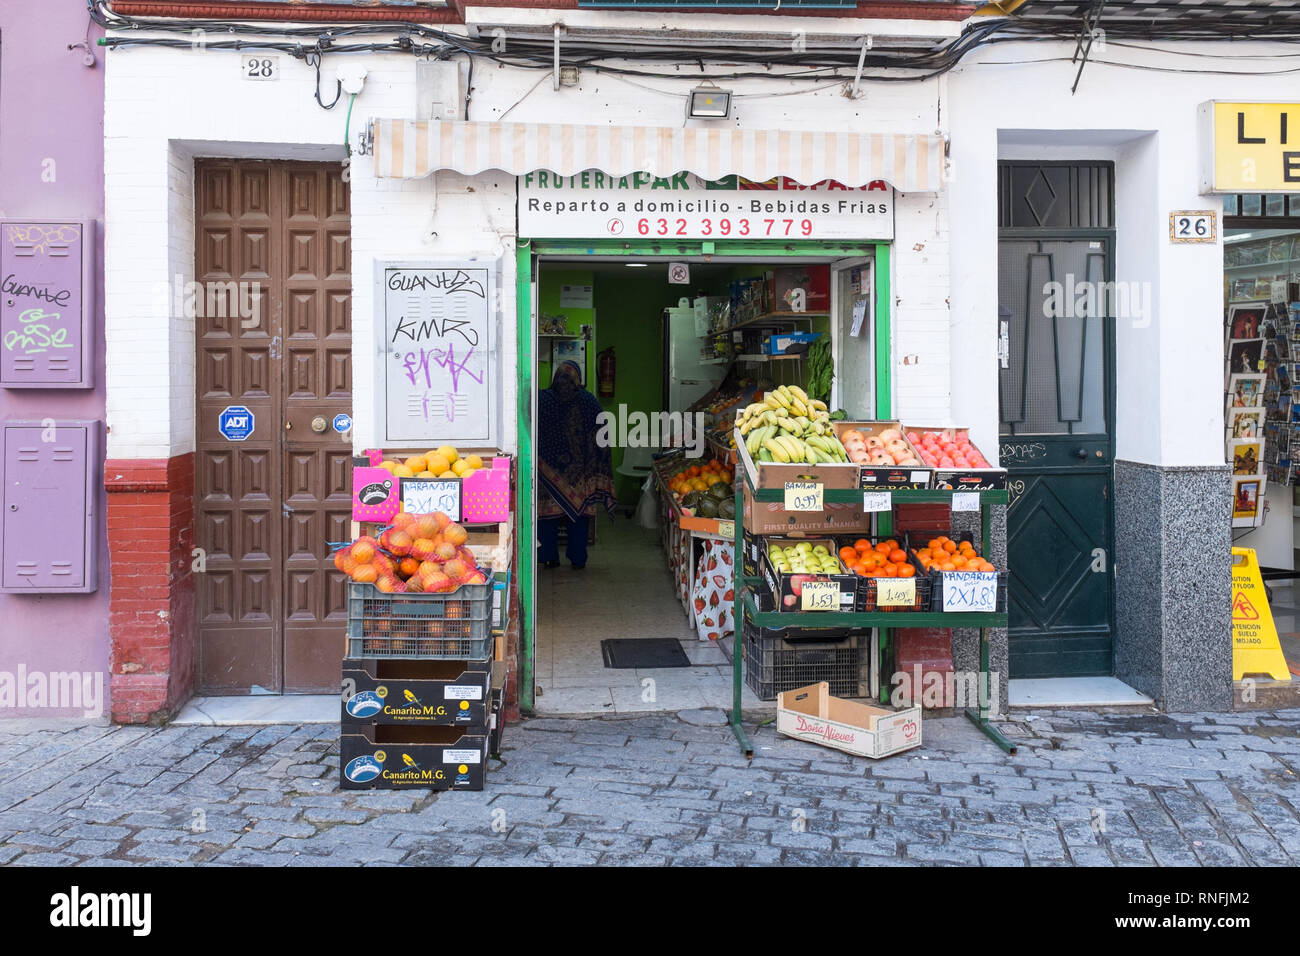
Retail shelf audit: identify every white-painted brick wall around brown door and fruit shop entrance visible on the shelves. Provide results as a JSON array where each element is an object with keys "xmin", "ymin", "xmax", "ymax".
[{"xmin": 105, "ymin": 36, "xmax": 951, "ymax": 468}]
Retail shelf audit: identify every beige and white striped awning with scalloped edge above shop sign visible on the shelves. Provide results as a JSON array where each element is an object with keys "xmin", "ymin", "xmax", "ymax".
[{"xmin": 373, "ymin": 120, "xmax": 944, "ymax": 193}]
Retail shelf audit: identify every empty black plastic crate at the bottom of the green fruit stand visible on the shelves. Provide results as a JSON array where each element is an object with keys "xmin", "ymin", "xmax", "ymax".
[{"xmin": 744, "ymin": 617, "xmax": 871, "ymax": 700}]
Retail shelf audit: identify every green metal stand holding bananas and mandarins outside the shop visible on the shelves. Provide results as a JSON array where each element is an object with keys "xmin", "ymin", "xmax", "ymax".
[{"xmin": 731, "ymin": 460, "xmax": 1017, "ymax": 757}]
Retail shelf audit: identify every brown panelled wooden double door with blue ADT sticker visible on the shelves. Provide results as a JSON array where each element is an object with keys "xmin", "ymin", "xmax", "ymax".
[{"xmin": 195, "ymin": 160, "xmax": 352, "ymax": 693}]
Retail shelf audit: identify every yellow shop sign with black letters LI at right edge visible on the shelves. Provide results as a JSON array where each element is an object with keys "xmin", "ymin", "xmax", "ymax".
[{"xmin": 1200, "ymin": 100, "xmax": 1300, "ymax": 193}]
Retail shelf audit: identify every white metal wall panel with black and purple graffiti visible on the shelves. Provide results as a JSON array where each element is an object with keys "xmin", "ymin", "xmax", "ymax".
[{"xmin": 376, "ymin": 260, "xmax": 501, "ymax": 447}]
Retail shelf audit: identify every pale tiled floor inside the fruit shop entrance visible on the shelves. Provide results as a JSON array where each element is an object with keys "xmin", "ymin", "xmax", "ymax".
[{"xmin": 536, "ymin": 515, "xmax": 771, "ymax": 714}]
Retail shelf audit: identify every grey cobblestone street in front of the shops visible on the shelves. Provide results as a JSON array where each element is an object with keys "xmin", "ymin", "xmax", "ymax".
[{"xmin": 0, "ymin": 710, "xmax": 1300, "ymax": 866}]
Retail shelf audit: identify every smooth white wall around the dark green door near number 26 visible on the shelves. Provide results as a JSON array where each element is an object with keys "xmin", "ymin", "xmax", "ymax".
[{"xmin": 945, "ymin": 42, "xmax": 1294, "ymax": 466}]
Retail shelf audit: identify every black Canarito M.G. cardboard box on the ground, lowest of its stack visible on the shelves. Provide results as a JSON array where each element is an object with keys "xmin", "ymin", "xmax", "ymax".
[{"xmin": 338, "ymin": 723, "xmax": 488, "ymax": 790}]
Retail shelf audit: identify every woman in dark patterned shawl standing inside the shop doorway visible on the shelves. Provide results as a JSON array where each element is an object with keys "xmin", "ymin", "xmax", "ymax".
[{"xmin": 537, "ymin": 362, "xmax": 618, "ymax": 570}]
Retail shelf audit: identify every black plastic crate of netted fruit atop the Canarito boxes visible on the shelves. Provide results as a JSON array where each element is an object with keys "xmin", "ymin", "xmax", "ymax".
[{"xmin": 347, "ymin": 581, "xmax": 493, "ymax": 661}]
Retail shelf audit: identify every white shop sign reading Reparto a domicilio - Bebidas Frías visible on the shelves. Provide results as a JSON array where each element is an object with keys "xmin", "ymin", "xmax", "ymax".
[{"xmin": 519, "ymin": 169, "xmax": 894, "ymax": 242}]
